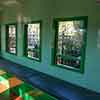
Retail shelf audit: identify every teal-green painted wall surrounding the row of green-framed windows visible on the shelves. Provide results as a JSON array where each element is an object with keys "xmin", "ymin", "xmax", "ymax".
[{"xmin": 1, "ymin": 0, "xmax": 100, "ymax": 92}]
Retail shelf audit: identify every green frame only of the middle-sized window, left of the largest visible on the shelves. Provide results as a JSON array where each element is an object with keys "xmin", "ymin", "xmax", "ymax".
[{"xmin": 23, "ymin": 20, "xmax": 42, "ymax": 62}]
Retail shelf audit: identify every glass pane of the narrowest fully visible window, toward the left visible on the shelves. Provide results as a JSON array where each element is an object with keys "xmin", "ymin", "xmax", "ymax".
[{"xmin": 8, "ymin": 25, "xmax": 16, "ymax": 54}]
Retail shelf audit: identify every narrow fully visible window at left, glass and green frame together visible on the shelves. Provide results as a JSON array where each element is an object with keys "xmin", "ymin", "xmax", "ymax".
[{"xmin": 6, "ymin": 24, "xmax": 17, "ymax": 54}]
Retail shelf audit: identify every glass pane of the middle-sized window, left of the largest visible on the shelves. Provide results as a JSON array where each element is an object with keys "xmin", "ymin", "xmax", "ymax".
[{"xmin": 27, "ymin": 23, "xmax": 40, "ymax": 59}]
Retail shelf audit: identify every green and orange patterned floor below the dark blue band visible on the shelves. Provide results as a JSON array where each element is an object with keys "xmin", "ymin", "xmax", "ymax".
[{"xmin": 0, "ymin": 70, "xmax": 56, "ymax": 100}]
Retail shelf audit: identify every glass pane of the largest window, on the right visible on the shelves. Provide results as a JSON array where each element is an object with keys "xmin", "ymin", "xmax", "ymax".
[{"xmin": 56, "ymin": 20, "xmax": 85, "ymax": 68}]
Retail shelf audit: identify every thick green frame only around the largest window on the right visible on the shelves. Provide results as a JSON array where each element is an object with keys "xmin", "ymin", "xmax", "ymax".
[{"xmin": 52, "ymin": 16, "xmax": 88, "ymax": 73}]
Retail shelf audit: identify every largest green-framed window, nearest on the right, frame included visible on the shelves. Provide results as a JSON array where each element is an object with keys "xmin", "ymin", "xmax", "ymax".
[{"xmin": 54, "ymin": 17, "xmax": 87, "ymax": 72}]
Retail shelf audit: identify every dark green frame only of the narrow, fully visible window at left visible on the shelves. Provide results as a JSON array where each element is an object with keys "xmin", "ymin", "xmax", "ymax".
[{"xmin": 6, "ymin": 23, "xmax": 18, "ymax": 55}]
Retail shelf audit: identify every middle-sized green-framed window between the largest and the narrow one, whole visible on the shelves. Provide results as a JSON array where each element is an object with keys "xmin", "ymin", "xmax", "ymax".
[{"xmin": 25, "ymin": 22, "xmax": 41, "ymax": 61}]
